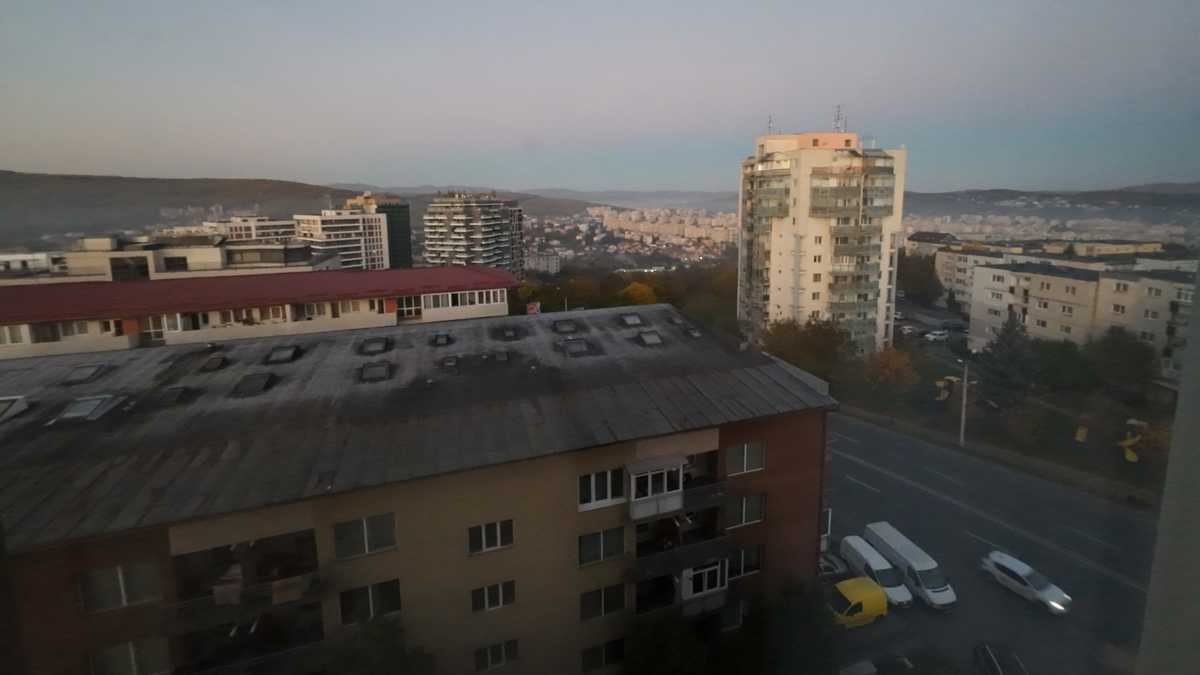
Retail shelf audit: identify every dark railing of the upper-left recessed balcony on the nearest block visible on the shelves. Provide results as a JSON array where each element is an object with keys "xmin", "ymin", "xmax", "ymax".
[{"xmin": 163, "ymin": 572, "xmax": 320, "ymax": 634}]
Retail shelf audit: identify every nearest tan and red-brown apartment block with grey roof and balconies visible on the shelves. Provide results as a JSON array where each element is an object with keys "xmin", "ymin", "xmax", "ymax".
[{"xmin": 0, "ymin": 305, "xmax": 835, "ymax": 675}]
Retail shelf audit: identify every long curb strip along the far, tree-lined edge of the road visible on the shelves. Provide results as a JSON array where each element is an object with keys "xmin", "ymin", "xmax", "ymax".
[{"xmin": 838, "ymin": 404, "xmax": 1162, "ymax": 512}]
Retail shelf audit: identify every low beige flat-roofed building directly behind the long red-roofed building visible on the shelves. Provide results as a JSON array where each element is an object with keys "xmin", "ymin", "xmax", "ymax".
[{"xmin": 0, "ymin": 234, "xmax": 337, "ymax": 286}]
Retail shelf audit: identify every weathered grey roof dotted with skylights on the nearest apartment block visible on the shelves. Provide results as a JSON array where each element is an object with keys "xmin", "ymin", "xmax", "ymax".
[{"xmin": 0, "ymin": 305, "xmax": 835, "ymax": 551}]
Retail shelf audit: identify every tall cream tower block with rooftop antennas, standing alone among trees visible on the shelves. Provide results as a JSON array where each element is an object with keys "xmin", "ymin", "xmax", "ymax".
[{"xmin": 738, "ymin": 132, "xmax": 906, "ymax": 351}]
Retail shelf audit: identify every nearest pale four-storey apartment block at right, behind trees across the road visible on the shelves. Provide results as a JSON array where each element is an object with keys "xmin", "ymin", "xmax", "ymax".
[{"xmin": 967, "ymin": 263, "xmax": 1196, "ymax": 380}]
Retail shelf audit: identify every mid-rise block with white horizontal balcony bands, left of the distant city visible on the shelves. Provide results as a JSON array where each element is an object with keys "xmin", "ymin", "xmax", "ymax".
[{"xmin": 425, "ymin": 192, "xmax": 524, "ymax": 274}]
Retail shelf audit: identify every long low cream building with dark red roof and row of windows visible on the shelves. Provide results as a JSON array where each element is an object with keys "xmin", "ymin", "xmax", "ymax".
[{"xmin": 0, "ymin": 267, "xmax": 517, "ymax": 359}]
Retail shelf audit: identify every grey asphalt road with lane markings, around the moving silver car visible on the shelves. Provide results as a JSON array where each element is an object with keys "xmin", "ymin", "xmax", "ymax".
[{"xmin": 826, "ymin": 414, "xmax": 1154, "ymax": 675}]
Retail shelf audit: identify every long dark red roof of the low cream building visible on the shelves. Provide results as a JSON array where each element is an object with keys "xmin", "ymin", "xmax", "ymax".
[{"xmin": 0, "ymin": 265, "xmax": 518, "ymax": 323}]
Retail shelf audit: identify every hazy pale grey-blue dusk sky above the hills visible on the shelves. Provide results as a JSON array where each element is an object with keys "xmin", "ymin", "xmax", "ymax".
[{"xmin": 0, "ymin": 0, "xmax": 1200, "ymax": 190}]
